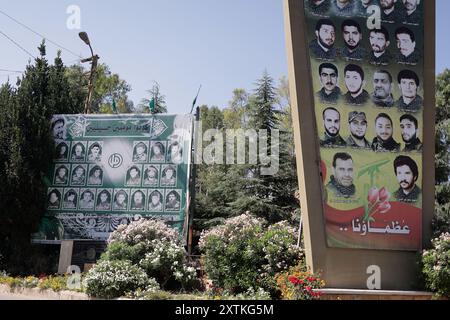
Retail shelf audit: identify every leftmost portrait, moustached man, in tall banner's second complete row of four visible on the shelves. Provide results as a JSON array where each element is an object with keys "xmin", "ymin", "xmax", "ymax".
[{"xmin": 316, "ymin": 62, "xmax": 342, "ymax": 104}]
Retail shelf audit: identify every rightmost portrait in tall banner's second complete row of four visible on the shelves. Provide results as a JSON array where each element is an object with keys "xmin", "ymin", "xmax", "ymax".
[{"xmin": 397, "ymin": 70, "xmax": 423, "ymax": 112}]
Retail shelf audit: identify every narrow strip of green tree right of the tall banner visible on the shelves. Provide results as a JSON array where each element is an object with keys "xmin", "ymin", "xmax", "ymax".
[{"xmin": 433, "ymin": 69, "xmax": 450, "ymax": 236}]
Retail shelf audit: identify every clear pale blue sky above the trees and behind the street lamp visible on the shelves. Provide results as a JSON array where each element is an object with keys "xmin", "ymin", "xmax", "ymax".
[{"xmin": 0, "ymin": 0, "xmax": 450, "ymax": 113}]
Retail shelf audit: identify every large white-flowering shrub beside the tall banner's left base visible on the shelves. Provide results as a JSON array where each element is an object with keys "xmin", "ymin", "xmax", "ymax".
[{"xmin": 199, "ymin": 214, "xmax": 301, "ymax": 294}]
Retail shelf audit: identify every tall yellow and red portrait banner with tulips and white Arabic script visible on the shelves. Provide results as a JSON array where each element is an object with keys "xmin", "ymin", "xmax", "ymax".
[{"xmin": 304, "ymin": 0, "xmax": 424, "ymax": 251}]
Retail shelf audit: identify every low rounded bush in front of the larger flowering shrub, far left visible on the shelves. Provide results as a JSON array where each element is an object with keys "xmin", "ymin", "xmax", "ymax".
[{"xmin": 83, "ymin": 261, "xmax": 154, "ymax": 299}]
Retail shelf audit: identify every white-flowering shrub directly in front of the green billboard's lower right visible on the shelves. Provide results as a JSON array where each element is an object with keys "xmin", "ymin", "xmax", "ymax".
[{"xmin": 102, "ymin": 219, "xmax": 196, "ymax": 289}]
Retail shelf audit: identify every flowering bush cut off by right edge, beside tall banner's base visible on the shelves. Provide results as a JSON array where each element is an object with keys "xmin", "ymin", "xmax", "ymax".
[{"xmin": 422, "ymin": 233, "xmax": 450, "ymax": 298}]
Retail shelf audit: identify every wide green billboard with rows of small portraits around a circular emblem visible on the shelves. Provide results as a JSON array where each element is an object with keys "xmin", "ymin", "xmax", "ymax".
[{"xmin": 34, "ymin": 115, "xmax": 194, "ymax": 240}]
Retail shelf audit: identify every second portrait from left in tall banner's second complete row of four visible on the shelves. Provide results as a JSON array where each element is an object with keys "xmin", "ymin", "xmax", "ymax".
[{"xmin": 344, "ymin": 64, "xmax": 370, "ymax": 105}]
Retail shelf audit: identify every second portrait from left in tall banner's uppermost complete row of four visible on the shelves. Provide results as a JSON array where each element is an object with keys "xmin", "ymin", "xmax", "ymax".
[{"xmin": 339, "ymin": 19, "xmax": 367, "ymax": 61}]
